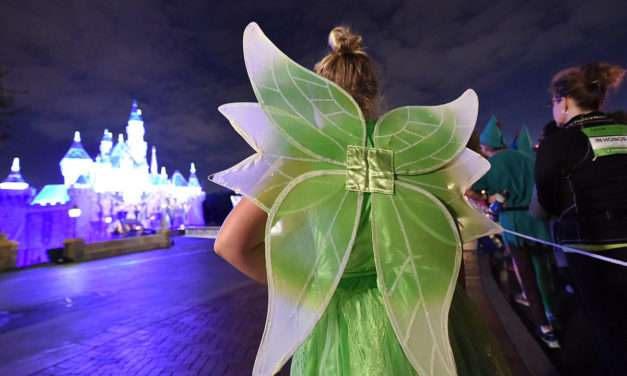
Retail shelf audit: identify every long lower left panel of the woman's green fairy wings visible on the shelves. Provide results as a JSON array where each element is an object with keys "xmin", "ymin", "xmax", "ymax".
[{"xmin": 253, "ymin": 170, "xmax": 362, "ymax": 375}]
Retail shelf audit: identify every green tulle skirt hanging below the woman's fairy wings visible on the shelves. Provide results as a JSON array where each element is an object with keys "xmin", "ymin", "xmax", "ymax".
[{"xmin": 291, "ymin": 275, "xmax": 510, "ymax": 376}]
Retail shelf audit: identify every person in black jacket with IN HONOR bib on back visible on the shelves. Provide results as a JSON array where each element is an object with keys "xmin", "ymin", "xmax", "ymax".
[{"xmin": 535, "ymin": 63, "xmax": 627, "ymax": 375}]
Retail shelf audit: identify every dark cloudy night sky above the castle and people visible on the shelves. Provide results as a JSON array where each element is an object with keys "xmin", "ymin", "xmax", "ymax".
[{"xmin": 0, "ymin": 0, "xmax": 627, "ymax": 191}]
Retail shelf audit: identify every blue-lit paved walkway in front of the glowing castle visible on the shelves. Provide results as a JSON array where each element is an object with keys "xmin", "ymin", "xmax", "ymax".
[{"xmin": 0, "ymin": 237, "xmax": 288, "ymax": 375}]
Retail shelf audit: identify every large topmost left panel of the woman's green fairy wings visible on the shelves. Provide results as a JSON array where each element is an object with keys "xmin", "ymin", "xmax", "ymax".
[{"xmin": 244, "ymin": 23, "xmax": 366, "ymax": 164}]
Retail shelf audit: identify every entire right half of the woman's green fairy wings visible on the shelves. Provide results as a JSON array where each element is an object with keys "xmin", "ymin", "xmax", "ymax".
[{"xmin": 371, "ymin": 90, "xmax": 494, "ymax": 375}]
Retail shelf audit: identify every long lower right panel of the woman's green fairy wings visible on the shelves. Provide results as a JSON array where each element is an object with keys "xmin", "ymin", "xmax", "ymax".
[{"xmin": 371, "ymin": 181, "xmax": 461, "ymax": 375}]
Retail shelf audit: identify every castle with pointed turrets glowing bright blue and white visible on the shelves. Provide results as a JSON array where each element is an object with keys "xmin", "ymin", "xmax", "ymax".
[{"xmin": 0, "ymin": 101, "xmax": 205, "ymax": 266}]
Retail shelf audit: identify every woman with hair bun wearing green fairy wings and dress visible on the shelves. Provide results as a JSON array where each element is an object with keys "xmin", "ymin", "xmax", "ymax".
[{"xmin": 211, "ymin": 23, "xmax": 509, "ymax": 375}]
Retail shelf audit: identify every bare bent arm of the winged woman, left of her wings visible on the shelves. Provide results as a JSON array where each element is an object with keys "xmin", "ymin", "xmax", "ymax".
[{"xmin": 213, "ymin": 198, "xmax": 267, "ymax": 284}]
